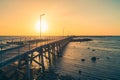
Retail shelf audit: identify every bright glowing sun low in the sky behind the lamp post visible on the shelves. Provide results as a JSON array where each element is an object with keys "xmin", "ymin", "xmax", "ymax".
[{"xmin": 35, "ymin": 20, "xmax": 48, "ymax": 32}]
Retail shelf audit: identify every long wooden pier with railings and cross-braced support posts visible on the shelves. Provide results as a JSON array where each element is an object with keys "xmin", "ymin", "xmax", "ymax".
[{"xmin": 0, "ymin": 37, "xmax": 73, "ymax": 80}]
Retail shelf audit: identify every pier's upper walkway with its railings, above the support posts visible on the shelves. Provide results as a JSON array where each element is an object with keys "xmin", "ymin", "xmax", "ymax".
[{"xmin": 0, "ymin": 36, "xmax": 67, "ymax": 62}]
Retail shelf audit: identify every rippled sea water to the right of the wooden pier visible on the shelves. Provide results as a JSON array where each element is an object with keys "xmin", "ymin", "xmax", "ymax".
[{"xmin": 54, "ymin": 37, "xmax": 120, "ymax": 80}]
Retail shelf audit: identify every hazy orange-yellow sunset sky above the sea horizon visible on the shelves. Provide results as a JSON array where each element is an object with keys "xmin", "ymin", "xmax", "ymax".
[{"xmin": 0, "ymin": 0, "xmax": 120, "ymax": 35}]
